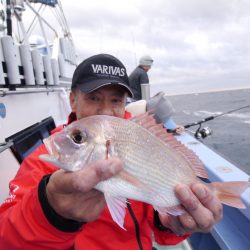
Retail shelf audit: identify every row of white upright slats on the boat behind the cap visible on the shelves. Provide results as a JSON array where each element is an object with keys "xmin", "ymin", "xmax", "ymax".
[{"xmin": 0, "ymin": 36, "xmax": 75, "ymax": 87}]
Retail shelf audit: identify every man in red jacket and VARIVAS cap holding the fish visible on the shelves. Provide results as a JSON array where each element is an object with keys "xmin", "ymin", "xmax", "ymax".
[{"xmin": 0, "ymin": 54, "xmax": 222, "ymax": 250}]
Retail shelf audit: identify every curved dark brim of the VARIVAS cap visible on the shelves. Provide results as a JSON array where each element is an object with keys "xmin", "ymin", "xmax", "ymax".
[{"xmin": 77, "ymin": 79, "xmax": 134, "ymax": 97}]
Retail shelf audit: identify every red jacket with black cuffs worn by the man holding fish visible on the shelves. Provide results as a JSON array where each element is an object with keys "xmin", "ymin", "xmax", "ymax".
[{"xmin": 0, "ymin": 112, "xmax": 187, "ymax": 250}]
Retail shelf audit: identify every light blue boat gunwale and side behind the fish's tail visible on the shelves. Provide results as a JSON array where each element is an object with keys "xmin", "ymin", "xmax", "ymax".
[{"xmin": 177, "ymin": 133, "xmax": 250, "ymax": 250}]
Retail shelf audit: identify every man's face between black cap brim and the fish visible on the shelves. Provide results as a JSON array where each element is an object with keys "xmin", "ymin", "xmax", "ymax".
[{"xmin": 70, "ymin": 85, "xmax": 127, "ymax": 119}]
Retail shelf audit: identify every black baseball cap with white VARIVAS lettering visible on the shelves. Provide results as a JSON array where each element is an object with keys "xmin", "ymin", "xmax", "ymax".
[{"xmin": 71, "ymin": 54, "xmax": 133, "ymax": 97}]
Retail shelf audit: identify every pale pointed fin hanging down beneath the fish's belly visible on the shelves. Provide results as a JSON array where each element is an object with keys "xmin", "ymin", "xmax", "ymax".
[{"xmin": 104, "ymin": 193, "xmax": 127, "ymax": 231}]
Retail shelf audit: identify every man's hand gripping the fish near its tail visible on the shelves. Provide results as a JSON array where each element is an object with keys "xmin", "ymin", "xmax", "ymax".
[{"xmin": 159, "ymin": 183, "xmax": 222, "ymax": 235}]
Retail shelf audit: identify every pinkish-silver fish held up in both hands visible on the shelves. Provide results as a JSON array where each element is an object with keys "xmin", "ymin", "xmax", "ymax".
[{"xmin": 41, "ymin": 113, "xmax": 250, "ymax": 228}]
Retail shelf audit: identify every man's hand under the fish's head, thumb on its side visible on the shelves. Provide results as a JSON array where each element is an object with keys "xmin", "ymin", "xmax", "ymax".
[{"xmin": 46, "ymin": 158, "xmax": 123, "ymax": 222}]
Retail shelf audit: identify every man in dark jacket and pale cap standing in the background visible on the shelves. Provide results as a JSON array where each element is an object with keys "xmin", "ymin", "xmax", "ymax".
[{"xmin": 129, "ymin": 56, "xmax": 153, "ymax": 100}]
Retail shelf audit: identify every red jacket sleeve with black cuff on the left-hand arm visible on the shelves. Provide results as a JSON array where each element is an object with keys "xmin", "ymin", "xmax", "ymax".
[{"xmin": 0, "ymin": 145, "xmax": 82, "ymax": 250}]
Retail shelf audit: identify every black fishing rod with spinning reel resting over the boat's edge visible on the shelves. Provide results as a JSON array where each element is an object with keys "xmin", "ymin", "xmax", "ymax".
[{"xmin": 184, "ymin": 105, "xmax": 250, "ymax": 139}]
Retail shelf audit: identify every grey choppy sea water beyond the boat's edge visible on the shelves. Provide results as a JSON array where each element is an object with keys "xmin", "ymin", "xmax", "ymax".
[{"xmin": 160, "ymin": 89, "xmax": 250, "ymax": 175}]
